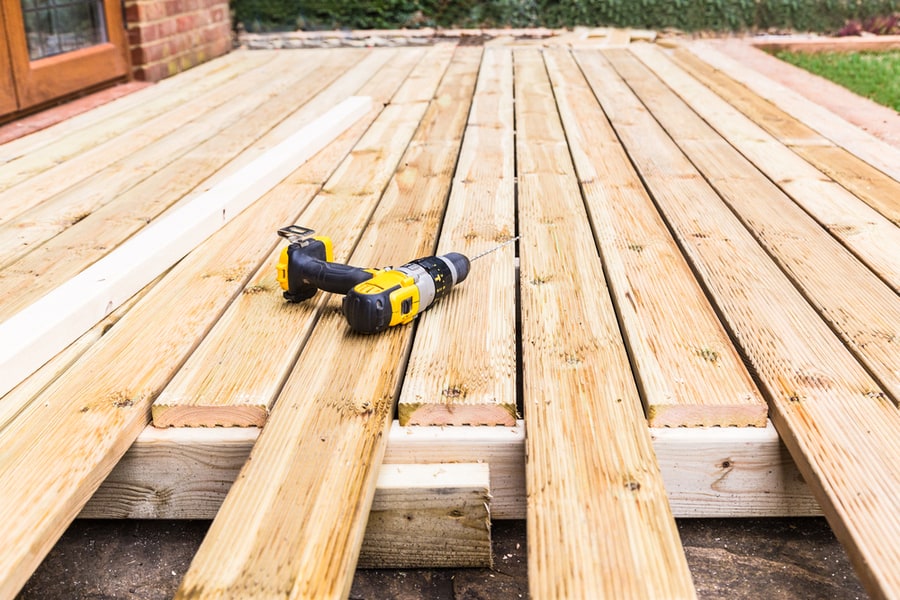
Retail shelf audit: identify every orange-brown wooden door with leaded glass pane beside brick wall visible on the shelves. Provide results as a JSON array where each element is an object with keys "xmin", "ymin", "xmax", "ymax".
[{"xmin": 0, "ymin": 0, "xmax": 130, "ymax": 114}]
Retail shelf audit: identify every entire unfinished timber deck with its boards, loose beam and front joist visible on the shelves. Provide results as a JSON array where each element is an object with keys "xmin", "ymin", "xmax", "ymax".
[{"xmin": 0, "ymin": 40, "xmax": 900, "ymax": 598}]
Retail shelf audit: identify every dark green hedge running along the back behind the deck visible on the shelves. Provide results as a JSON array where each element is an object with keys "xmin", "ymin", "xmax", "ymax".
[{"xmin": 237, "ymin": 0, "xmax": 900, "ymax": 32}]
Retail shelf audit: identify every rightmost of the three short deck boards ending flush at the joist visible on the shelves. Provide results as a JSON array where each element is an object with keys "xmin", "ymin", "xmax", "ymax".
[{"xmin": 545, "ymin": 51, "xmax": 766, "ymax": 427}]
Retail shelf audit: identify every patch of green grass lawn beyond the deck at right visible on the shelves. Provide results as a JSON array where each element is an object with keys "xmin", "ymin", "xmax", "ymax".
[{"xmin": 775, "ymin": 50, "xmax": 900, "ymax": 111}]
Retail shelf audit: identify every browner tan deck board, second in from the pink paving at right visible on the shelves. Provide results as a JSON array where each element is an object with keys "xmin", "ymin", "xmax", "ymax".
[{"xmin": 669, "ymin": 48, "xmax": 900, "ymax": 225}]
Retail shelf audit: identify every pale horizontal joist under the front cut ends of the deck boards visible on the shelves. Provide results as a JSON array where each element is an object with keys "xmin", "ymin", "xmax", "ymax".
[{"xmin": 80, "ymin": 421, "xmax": 822, "ymax": 524}]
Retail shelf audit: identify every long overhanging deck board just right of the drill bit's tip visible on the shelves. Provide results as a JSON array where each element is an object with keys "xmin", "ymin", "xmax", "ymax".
[{"xmin": 515, "ymin": 50, "xmax": 695, "ymax": 598}]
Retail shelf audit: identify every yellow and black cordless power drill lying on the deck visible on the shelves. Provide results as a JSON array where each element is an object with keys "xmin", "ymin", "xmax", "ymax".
[{"xmin": 277, "ymin": 225, "xmax": 488, "ymax": 333}]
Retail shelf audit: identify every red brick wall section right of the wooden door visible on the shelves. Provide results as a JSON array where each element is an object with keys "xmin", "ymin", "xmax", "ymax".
[{"xmin": 125, "ymin": 0, "xmax": 231, "ymax": 81}]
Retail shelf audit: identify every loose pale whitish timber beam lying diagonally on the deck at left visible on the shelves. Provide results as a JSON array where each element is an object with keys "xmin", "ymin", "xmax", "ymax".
[{"xmin": 0, "ymin": 97, "xmax": 371, "ymax": 395}]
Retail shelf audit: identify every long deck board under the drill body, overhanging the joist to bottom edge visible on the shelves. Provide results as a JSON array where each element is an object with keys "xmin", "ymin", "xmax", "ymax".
[{"xmin": 176, "ymin": 48, "xmax": 480, "ymax": 598}]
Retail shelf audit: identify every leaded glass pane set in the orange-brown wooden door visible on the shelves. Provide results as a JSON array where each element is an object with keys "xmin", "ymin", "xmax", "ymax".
[{"xmin": 22, "ymin": 0, "xmax": 108, "ymax": 60}]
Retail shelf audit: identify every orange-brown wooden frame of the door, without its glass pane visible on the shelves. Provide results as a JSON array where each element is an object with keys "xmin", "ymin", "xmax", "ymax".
[{"xmin": 0, "ymin": 0, "xmax": 131, "ymax": 110}]
